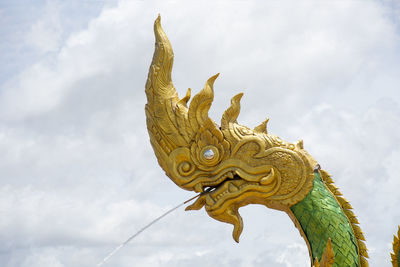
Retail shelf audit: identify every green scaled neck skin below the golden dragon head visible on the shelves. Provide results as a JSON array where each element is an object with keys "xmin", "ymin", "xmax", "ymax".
[{"xmin": 290, "ymin": 173, "xmax": 360, "ymax": 267}]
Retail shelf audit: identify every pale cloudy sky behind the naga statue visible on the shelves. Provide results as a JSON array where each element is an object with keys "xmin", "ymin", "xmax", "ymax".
[{"xmin": 0, "ymin": 0, "xmax": 400, "ymax": 267}]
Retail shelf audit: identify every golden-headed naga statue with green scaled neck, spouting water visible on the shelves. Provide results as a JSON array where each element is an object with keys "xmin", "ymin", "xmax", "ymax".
[{"xmin": 146, "ymin": 17, "xmax": 400, "ymax": 267}]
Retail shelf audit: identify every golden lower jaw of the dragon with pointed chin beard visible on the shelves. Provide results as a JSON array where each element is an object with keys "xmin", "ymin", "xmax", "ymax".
[{"xmin": 186, "ymin": 171, "xmax": 280, "ymax": 242}]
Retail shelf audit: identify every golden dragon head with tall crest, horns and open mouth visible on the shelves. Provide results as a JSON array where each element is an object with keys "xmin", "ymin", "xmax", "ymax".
[{"xmin": 146, "ymin": 17, "xmax": 315, "ymax": 242}]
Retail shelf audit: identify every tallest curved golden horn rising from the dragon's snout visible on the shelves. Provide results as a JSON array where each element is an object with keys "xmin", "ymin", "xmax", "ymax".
[{"xmin": 146, "ymin": 15, "xmax": 187, "ymax": 157}]
